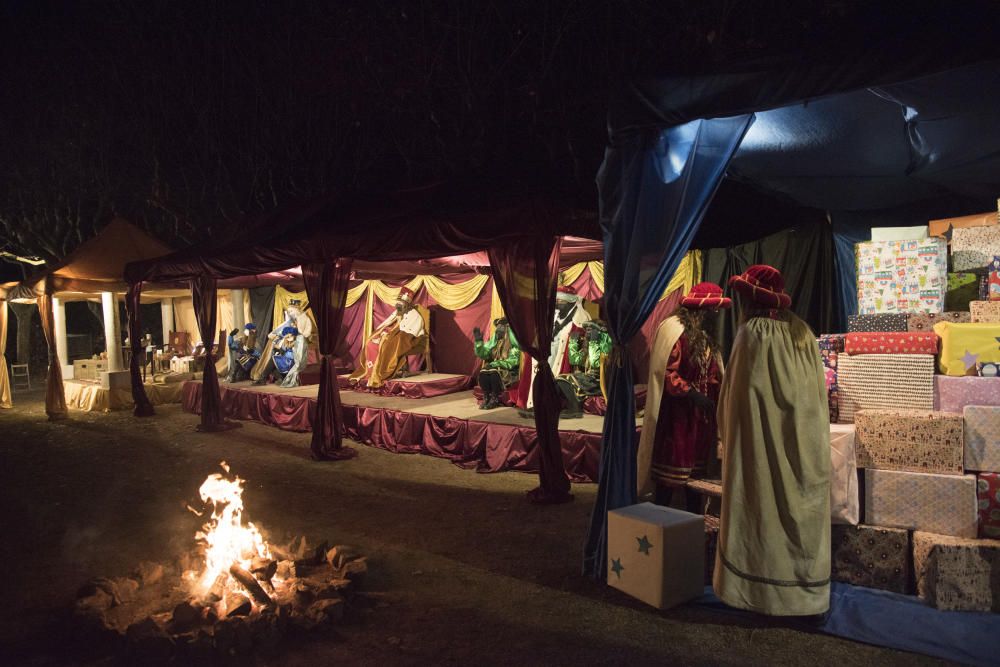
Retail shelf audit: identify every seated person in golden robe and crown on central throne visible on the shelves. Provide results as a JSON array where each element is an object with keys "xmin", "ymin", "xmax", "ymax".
[{"xmin": 348, "ymin": 287, "xmax": 427, "ymax": 389}]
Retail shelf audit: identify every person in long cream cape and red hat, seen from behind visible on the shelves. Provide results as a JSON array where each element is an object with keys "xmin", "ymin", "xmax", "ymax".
[{"xmin": 713, "ymin": 264, "xmax": 830, "ymax": 616}]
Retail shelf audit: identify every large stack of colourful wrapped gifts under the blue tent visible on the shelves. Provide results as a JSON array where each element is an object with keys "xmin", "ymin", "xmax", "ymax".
[{"xmin": 819, "ymin": 214, "xmax": 1000, "ymax": 611}]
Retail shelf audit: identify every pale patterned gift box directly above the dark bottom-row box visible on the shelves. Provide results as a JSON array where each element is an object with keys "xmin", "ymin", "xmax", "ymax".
[{"xmin": 865, "ymin": 468, "xmax": 979, "ymax": 537}]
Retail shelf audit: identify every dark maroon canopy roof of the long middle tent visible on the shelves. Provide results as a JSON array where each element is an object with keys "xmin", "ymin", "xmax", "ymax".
[{"xmin": 125, "ymin": 186, "xmax": 599, "ymax": 287}]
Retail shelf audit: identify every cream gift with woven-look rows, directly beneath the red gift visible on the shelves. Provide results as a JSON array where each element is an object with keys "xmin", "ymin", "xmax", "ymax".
[{"xmin": 837, "ymin": 354, "xmax": 934, "ymax": 424}]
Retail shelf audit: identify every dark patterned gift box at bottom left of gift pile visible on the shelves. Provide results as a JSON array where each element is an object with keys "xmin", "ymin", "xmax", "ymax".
[{"xmin": 830, "ymin": 524, "xmax": 910, "ymax": 594}]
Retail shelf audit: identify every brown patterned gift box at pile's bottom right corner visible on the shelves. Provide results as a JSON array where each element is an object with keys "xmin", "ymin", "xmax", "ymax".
[{"xmin": 913, "ymin": 531, "xmax": 1000, "ymax": 611}]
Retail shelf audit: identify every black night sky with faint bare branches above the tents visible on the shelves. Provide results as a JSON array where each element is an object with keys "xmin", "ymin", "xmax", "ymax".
[{"xmin": 0, "ymin": 0, "xmax": 996, "ymax": 259}]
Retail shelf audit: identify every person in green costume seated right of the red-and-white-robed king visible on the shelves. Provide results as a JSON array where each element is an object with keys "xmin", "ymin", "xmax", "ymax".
[{"xmin": 556, "ymin": 320, "xmax": 613, "ymax": 419}]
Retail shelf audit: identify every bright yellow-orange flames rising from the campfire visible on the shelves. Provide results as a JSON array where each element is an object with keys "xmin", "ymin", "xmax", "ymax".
[{"xmin": 189, "ymin": 461, "xmax": 271, "ymax": 595}]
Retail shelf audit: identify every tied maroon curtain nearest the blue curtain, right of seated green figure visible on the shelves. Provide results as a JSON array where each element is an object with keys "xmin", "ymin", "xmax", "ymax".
[{"xmin": 489, "ymin": 236, "xmax": 573, "ymax": 503}]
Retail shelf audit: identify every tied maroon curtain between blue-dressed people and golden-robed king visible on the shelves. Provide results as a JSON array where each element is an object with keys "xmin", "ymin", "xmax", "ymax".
[{"xmin": 302, "ymin": 257, "xmax": 356, "ymax": 461}]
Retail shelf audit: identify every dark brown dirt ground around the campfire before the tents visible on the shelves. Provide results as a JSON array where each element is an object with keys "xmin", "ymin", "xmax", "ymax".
[{"xmin": 0, "ymin": 392, "xmax": 935, "ymax": 667}]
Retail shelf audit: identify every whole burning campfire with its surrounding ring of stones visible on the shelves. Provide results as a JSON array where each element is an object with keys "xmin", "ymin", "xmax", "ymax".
[{"xmin": 74, "ymin": 462, "xmax": 368, "ymax": 660}]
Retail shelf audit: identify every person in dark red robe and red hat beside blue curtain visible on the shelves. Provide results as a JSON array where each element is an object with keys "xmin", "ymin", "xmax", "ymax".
[{"xmin": 650, "ymin": 283, "xmax": 732, "ymax": 512}]
